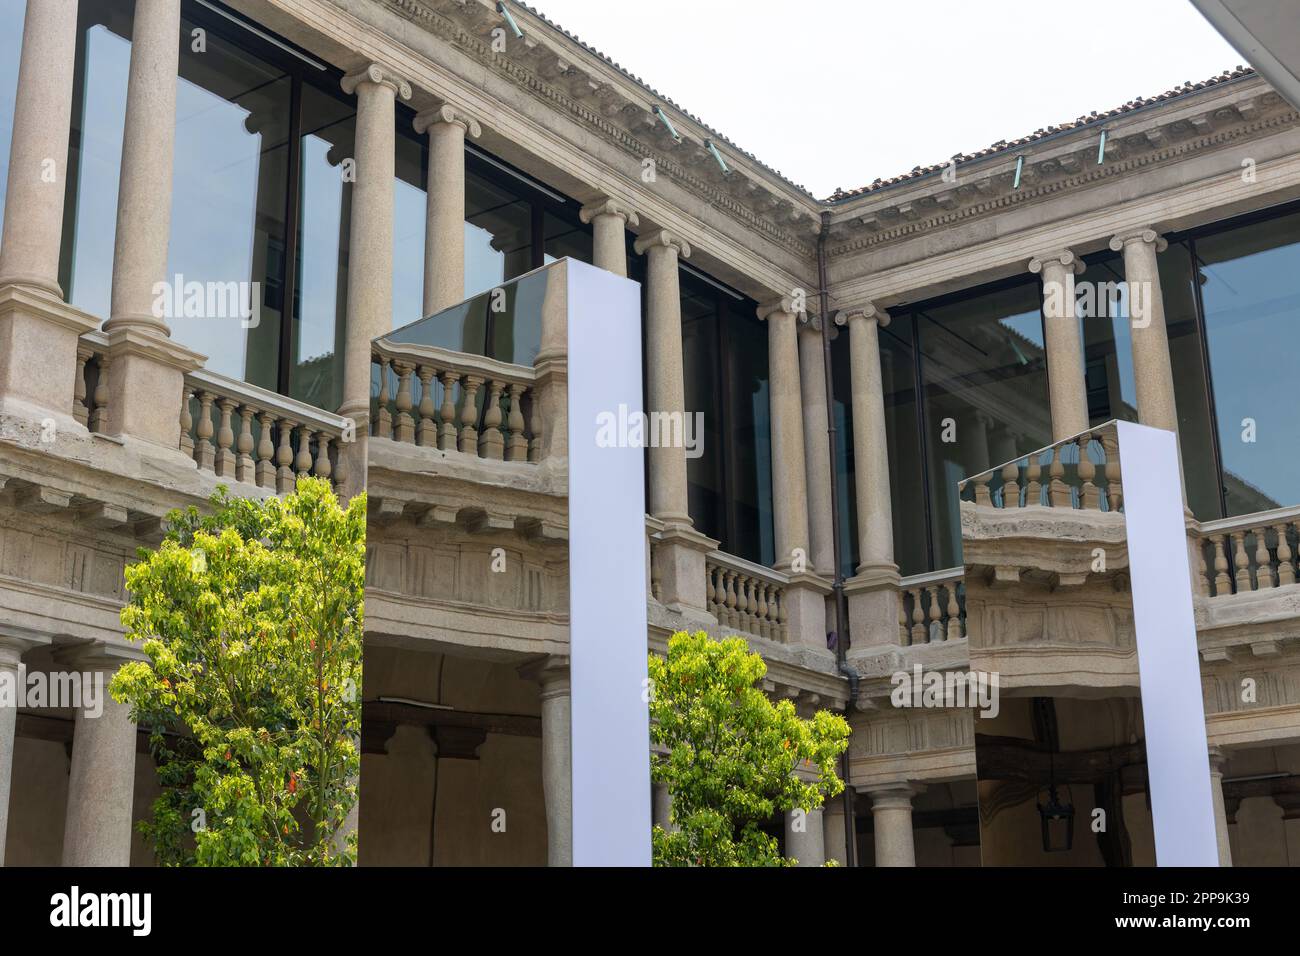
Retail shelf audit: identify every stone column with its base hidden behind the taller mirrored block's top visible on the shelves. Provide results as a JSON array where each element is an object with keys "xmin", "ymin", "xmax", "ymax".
[{"xmin": 413, "ymin": 102, "xmax": 482, "ymax": 316}]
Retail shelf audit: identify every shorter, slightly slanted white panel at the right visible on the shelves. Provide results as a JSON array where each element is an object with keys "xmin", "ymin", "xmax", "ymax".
[{"xmin": 1118, "ymin": 421, "xmax": 1218, "ymax": 866}]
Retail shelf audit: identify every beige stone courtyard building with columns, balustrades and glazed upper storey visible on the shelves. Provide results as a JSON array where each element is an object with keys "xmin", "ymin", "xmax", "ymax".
[{"xmin": 0, "ymin": 0, "xmax": 1300, "ymax": 865}]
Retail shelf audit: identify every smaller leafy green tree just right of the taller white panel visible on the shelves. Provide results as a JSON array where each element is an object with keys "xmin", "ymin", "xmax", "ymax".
[{"xmin": 650, "ymin": 631, "xmax": 849, "ymax": 866}]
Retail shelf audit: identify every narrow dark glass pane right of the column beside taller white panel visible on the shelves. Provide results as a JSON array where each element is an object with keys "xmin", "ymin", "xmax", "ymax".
[{"xmin": 686, "ymin": 272, "xmax": 727, "ymax": 550}]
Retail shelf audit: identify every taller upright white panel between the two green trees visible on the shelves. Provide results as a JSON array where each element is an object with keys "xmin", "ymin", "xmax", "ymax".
[{"xmin": 567, "ymin": 259, "xmax": 650, "ymax": 866}]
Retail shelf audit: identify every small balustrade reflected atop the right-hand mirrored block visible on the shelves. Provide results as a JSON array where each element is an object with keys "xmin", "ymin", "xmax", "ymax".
[{"xmin": 959, "ymin": 425, "xmax": 1123, "ymax": 511}]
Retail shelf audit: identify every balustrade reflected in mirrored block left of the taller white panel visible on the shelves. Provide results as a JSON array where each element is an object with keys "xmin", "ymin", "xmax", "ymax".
[{"xmin": 371, "ymin": 339, "xmax": 543, "ymax": 462}]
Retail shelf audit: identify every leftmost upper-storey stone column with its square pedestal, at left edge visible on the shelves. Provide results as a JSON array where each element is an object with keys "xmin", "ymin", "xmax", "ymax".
[{"xmin": 0, "ymin": 0, "xmax": 98, "ymax": 432}]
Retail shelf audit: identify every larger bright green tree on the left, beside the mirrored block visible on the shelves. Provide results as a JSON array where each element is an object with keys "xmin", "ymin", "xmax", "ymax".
[{"xmin": 109, "ymin": 479, "xmax": 365, "ymax": 866}]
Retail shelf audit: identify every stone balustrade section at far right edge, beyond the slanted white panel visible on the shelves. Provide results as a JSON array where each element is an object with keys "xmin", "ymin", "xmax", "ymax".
[{"xmin": 1197, "ymin": 507, "xmax": 1300, "ymax": 597}]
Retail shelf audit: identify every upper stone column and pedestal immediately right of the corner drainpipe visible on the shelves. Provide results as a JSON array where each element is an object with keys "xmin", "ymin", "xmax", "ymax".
[{"xmin": 835, "ymin": 303, "xmax": 898, "ymax": 646}]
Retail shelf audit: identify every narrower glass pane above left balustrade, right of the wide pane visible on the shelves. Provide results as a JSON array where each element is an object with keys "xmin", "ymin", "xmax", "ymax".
[{"xmin": 289, "ymin": 86, "xmax": 356, "ymax": 408}]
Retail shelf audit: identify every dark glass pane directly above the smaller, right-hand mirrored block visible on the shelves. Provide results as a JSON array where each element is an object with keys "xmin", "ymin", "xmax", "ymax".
[{"xmin": 914, "ymin": 282, "xmax": 1052, "ymax": 568}]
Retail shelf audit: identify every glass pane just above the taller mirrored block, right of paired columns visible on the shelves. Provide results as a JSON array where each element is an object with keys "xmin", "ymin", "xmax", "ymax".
[{"xmin": 465, "ymin": 169, "xmax": 533, "ymax": 298}]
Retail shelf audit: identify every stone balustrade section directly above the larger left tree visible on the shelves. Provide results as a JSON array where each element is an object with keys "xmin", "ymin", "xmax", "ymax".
[{"xmin": 181, "ymin": 369, "xmax": 350, "ymax": 494}]
